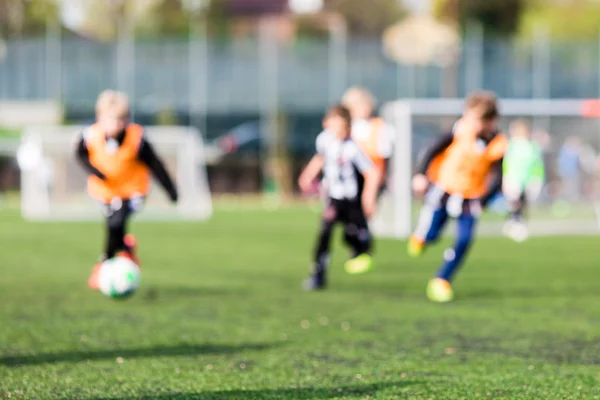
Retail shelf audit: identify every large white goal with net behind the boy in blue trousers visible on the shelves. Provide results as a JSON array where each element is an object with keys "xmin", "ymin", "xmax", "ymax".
[{"xmin": 373, "ymin": 99, "xmax": 600, "ymax": 238}]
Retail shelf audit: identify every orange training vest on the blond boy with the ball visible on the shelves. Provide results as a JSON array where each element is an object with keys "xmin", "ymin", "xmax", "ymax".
[{"xmin": 85, "ymin": 124, "xmax": 151, "ymax": 202}]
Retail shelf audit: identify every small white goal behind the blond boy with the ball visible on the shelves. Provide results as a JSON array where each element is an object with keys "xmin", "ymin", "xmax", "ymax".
[{"xmin": 17, "ymin": 126, "xmax": 212, "ymax": 221}]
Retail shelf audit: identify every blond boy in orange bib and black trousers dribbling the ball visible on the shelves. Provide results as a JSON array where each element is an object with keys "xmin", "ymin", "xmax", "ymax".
[{"xmin": 77, "ymin": 90, "xmax": 177, "ymax": 290}]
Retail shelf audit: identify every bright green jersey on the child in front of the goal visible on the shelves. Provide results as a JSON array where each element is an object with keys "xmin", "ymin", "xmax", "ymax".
[{"xmin": 502, "ymin": 138, "xmax": 544, "ymax": 188}]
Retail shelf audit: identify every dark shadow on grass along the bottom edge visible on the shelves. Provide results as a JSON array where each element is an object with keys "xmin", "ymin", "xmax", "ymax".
[{"xmin": 86, "ymin": 382, "xmax": 415, "ymax": 400}]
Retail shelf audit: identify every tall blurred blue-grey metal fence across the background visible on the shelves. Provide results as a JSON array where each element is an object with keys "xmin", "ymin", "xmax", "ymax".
[{"xmin": 0, "ymin": 28, "xmax": 600, "ymax": 114}]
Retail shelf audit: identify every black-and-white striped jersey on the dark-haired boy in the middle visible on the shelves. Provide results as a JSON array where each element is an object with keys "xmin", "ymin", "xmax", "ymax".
[{"xmin": 317, "ymin": 131, "xmax": 373, "ymax": 200}]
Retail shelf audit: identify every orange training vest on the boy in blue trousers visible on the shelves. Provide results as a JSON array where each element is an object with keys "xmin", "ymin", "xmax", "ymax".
[{"xmin": 427, "ymin": 121, "xmax": 508, "ymax": 199}]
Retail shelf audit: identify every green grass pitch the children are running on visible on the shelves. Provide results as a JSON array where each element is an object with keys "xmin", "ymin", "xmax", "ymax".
[{"xmin": 0, "ymin": 209, "xmax": 600, "ymax": 400}]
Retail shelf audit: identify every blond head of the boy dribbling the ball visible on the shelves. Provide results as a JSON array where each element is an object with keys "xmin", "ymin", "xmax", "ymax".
[{"xmin": 96, "ymin": 90, "xmax": 129, "ymax": 137}]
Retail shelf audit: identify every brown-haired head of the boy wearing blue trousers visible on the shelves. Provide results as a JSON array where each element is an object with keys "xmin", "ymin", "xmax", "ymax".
[{"xmin": 464, "ymin": 91, "xmax": 498, "ymax": 137}]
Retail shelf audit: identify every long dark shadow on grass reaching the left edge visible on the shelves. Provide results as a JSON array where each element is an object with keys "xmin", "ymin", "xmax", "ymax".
[{"xmin": 0, "ymin": 343, "xmax": 274, "ymax": 367}]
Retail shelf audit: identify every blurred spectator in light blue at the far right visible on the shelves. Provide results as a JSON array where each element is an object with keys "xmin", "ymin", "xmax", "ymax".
[{"xmin": 558, "ymin": 136, "xmax": 583, "ymax": 201}]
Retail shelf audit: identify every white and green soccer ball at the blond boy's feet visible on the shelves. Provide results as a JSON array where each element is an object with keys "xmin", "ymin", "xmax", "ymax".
[{"xmin": 98, "ymin": 257, "xmax": 141, "ymax": 298}]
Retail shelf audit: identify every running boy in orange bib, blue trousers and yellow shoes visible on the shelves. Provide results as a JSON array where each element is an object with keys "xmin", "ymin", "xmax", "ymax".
[{"xmin": 408, "ymin": 92, "xmax": 508, "ymax": 302}]
